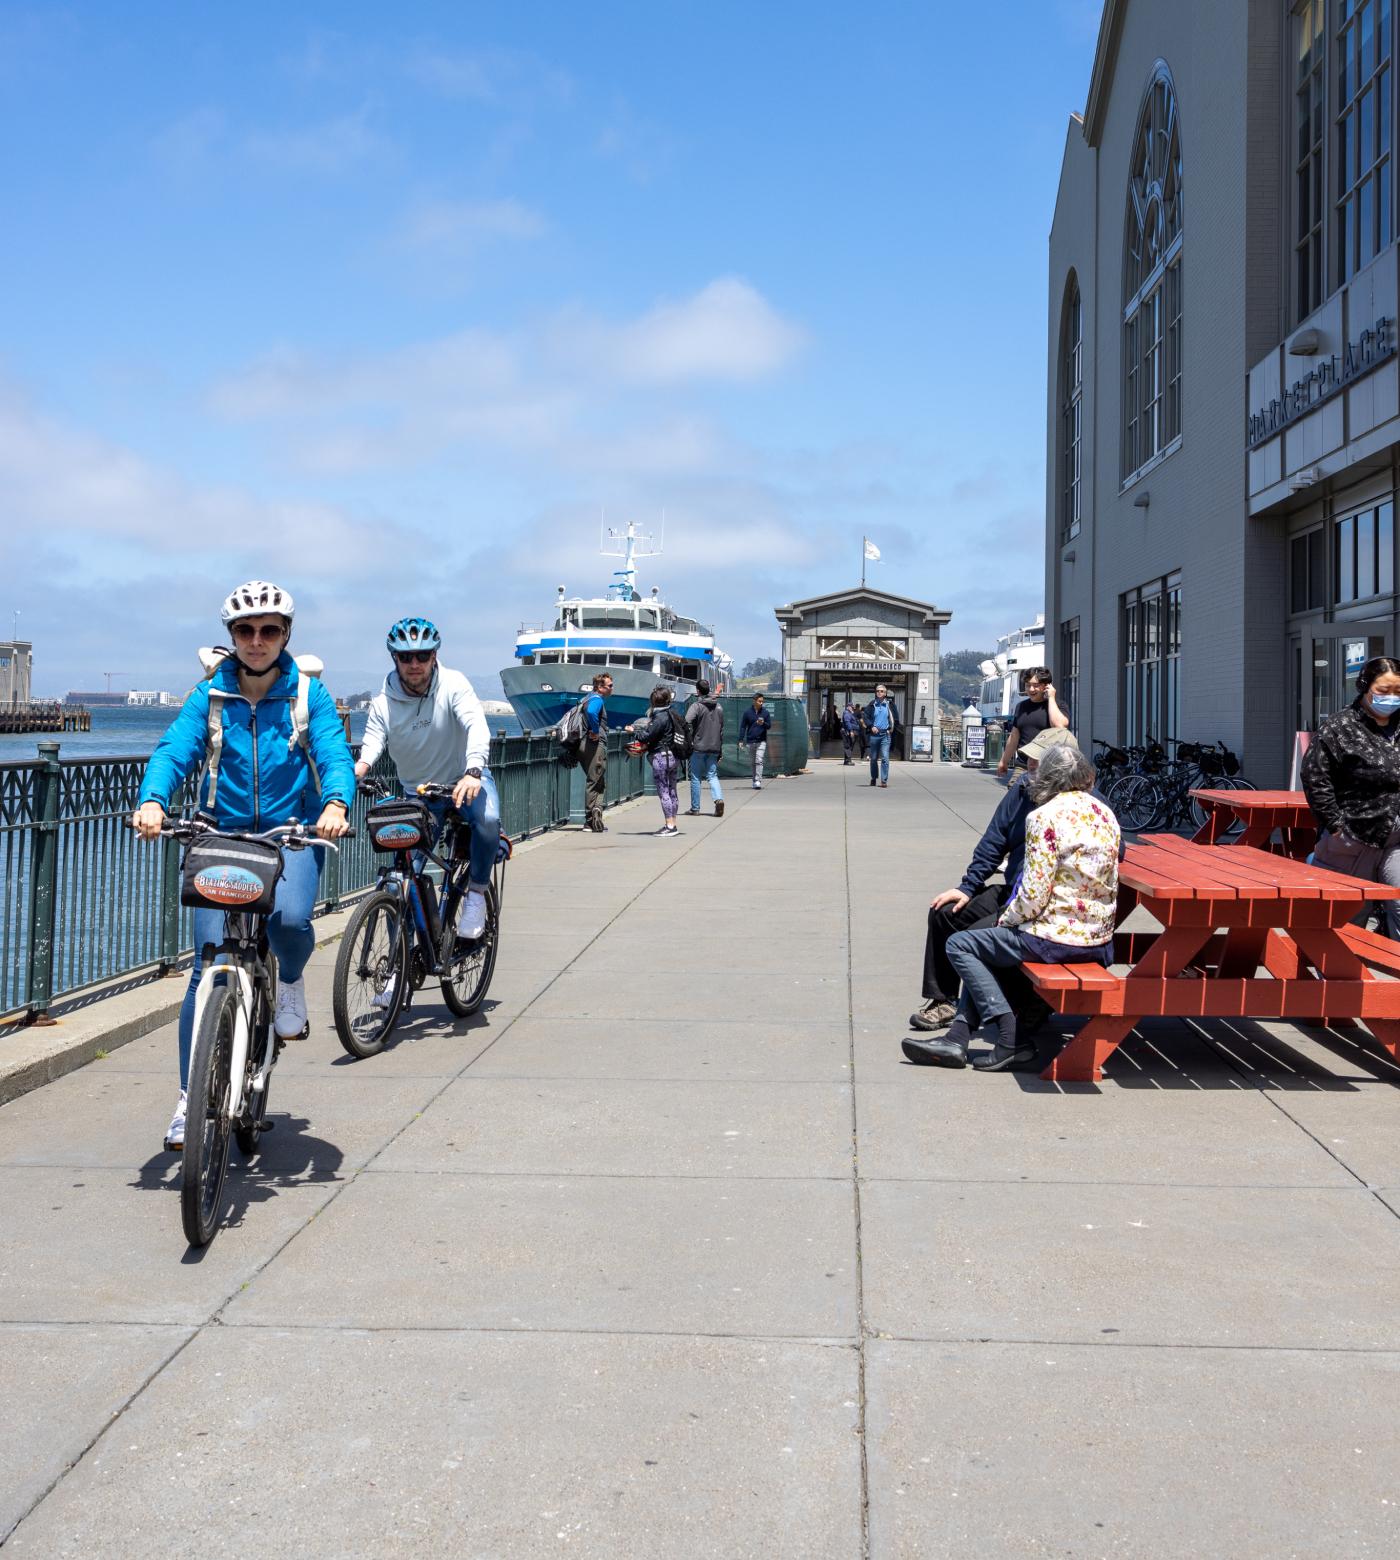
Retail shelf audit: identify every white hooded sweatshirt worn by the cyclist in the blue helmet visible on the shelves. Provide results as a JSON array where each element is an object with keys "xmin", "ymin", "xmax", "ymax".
[{"xmin": 359, "ymin": 666, "xmax": 492, "ymax": 791}]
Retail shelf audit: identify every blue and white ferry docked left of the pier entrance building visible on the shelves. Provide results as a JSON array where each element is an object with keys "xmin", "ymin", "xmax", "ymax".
[{"xmin": 501, "ymin": 521, "xmax": 734, "ymax": 732}]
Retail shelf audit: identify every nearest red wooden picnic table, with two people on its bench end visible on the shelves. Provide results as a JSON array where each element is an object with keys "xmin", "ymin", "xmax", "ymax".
[{"xmin": 1025, "ymin": 835, "xmax": 1400, "ymax": 1083}]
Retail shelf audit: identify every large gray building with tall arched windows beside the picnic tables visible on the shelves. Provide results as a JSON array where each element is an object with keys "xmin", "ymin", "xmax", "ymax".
[{"xmin": 1046, "ymin": 0, "xmax": 1400, "ymax": 785}]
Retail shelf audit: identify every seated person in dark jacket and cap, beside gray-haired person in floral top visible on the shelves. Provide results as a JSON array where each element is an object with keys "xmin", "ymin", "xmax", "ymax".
[{"xmin": 904, "ymin": 727, "xmax": 1103, "ymax": 1061}]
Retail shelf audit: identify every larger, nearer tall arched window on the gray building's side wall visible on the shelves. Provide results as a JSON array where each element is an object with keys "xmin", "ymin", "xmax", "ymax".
[{"xmin": 1122, "ymin": 61, "xmax": 1181, "ymax": 479}]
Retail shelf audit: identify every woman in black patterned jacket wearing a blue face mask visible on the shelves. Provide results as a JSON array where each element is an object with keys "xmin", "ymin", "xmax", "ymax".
[{"xmin": 1303, "ymin": 655, "xmax": 1400, "ymax": 938}]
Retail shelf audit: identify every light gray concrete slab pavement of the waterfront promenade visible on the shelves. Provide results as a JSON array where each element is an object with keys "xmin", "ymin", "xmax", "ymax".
[{"xmin": 0, "ymin": 763, "xmax": 1400, "ymax": 1560}]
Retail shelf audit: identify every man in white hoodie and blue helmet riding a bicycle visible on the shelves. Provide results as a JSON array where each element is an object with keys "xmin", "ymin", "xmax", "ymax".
[{"xmin": 354, "ymin": 618, "xmax": 501, "ymax": 939}]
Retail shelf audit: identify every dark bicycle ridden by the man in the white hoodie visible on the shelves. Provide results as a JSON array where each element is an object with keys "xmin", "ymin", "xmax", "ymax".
[{"xmin": 332, "ymin": 777, "xmax": 513, "ymax": 1059}]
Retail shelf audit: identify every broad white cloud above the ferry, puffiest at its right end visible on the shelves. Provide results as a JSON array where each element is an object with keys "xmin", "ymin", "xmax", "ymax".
[{"xmin": 202, "ymin": 278, "xmax": 802, "ymax": 473}]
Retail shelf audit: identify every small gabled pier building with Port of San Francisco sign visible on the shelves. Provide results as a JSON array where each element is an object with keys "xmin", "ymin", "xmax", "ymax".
[{"xmin": 774, "ymin": 585, "xmax": 952, "ymax": 758}]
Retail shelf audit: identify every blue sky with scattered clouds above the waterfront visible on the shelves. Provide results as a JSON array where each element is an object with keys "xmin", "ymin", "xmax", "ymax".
[{"xmin": 0, "ymin": 0, "xmax": 1099, "ymax": 693}]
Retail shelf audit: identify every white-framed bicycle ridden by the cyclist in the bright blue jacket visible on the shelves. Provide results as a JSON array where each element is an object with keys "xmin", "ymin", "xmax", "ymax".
[{"xmin": 136, "ymin": 819, "xmax": 348, "ymax": 1246}]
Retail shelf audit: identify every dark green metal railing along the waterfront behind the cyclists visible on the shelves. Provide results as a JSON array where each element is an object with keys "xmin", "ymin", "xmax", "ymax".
[{"xmin": 0, "ymin": 732, "xmax": 651, "ymax": 1022}]
